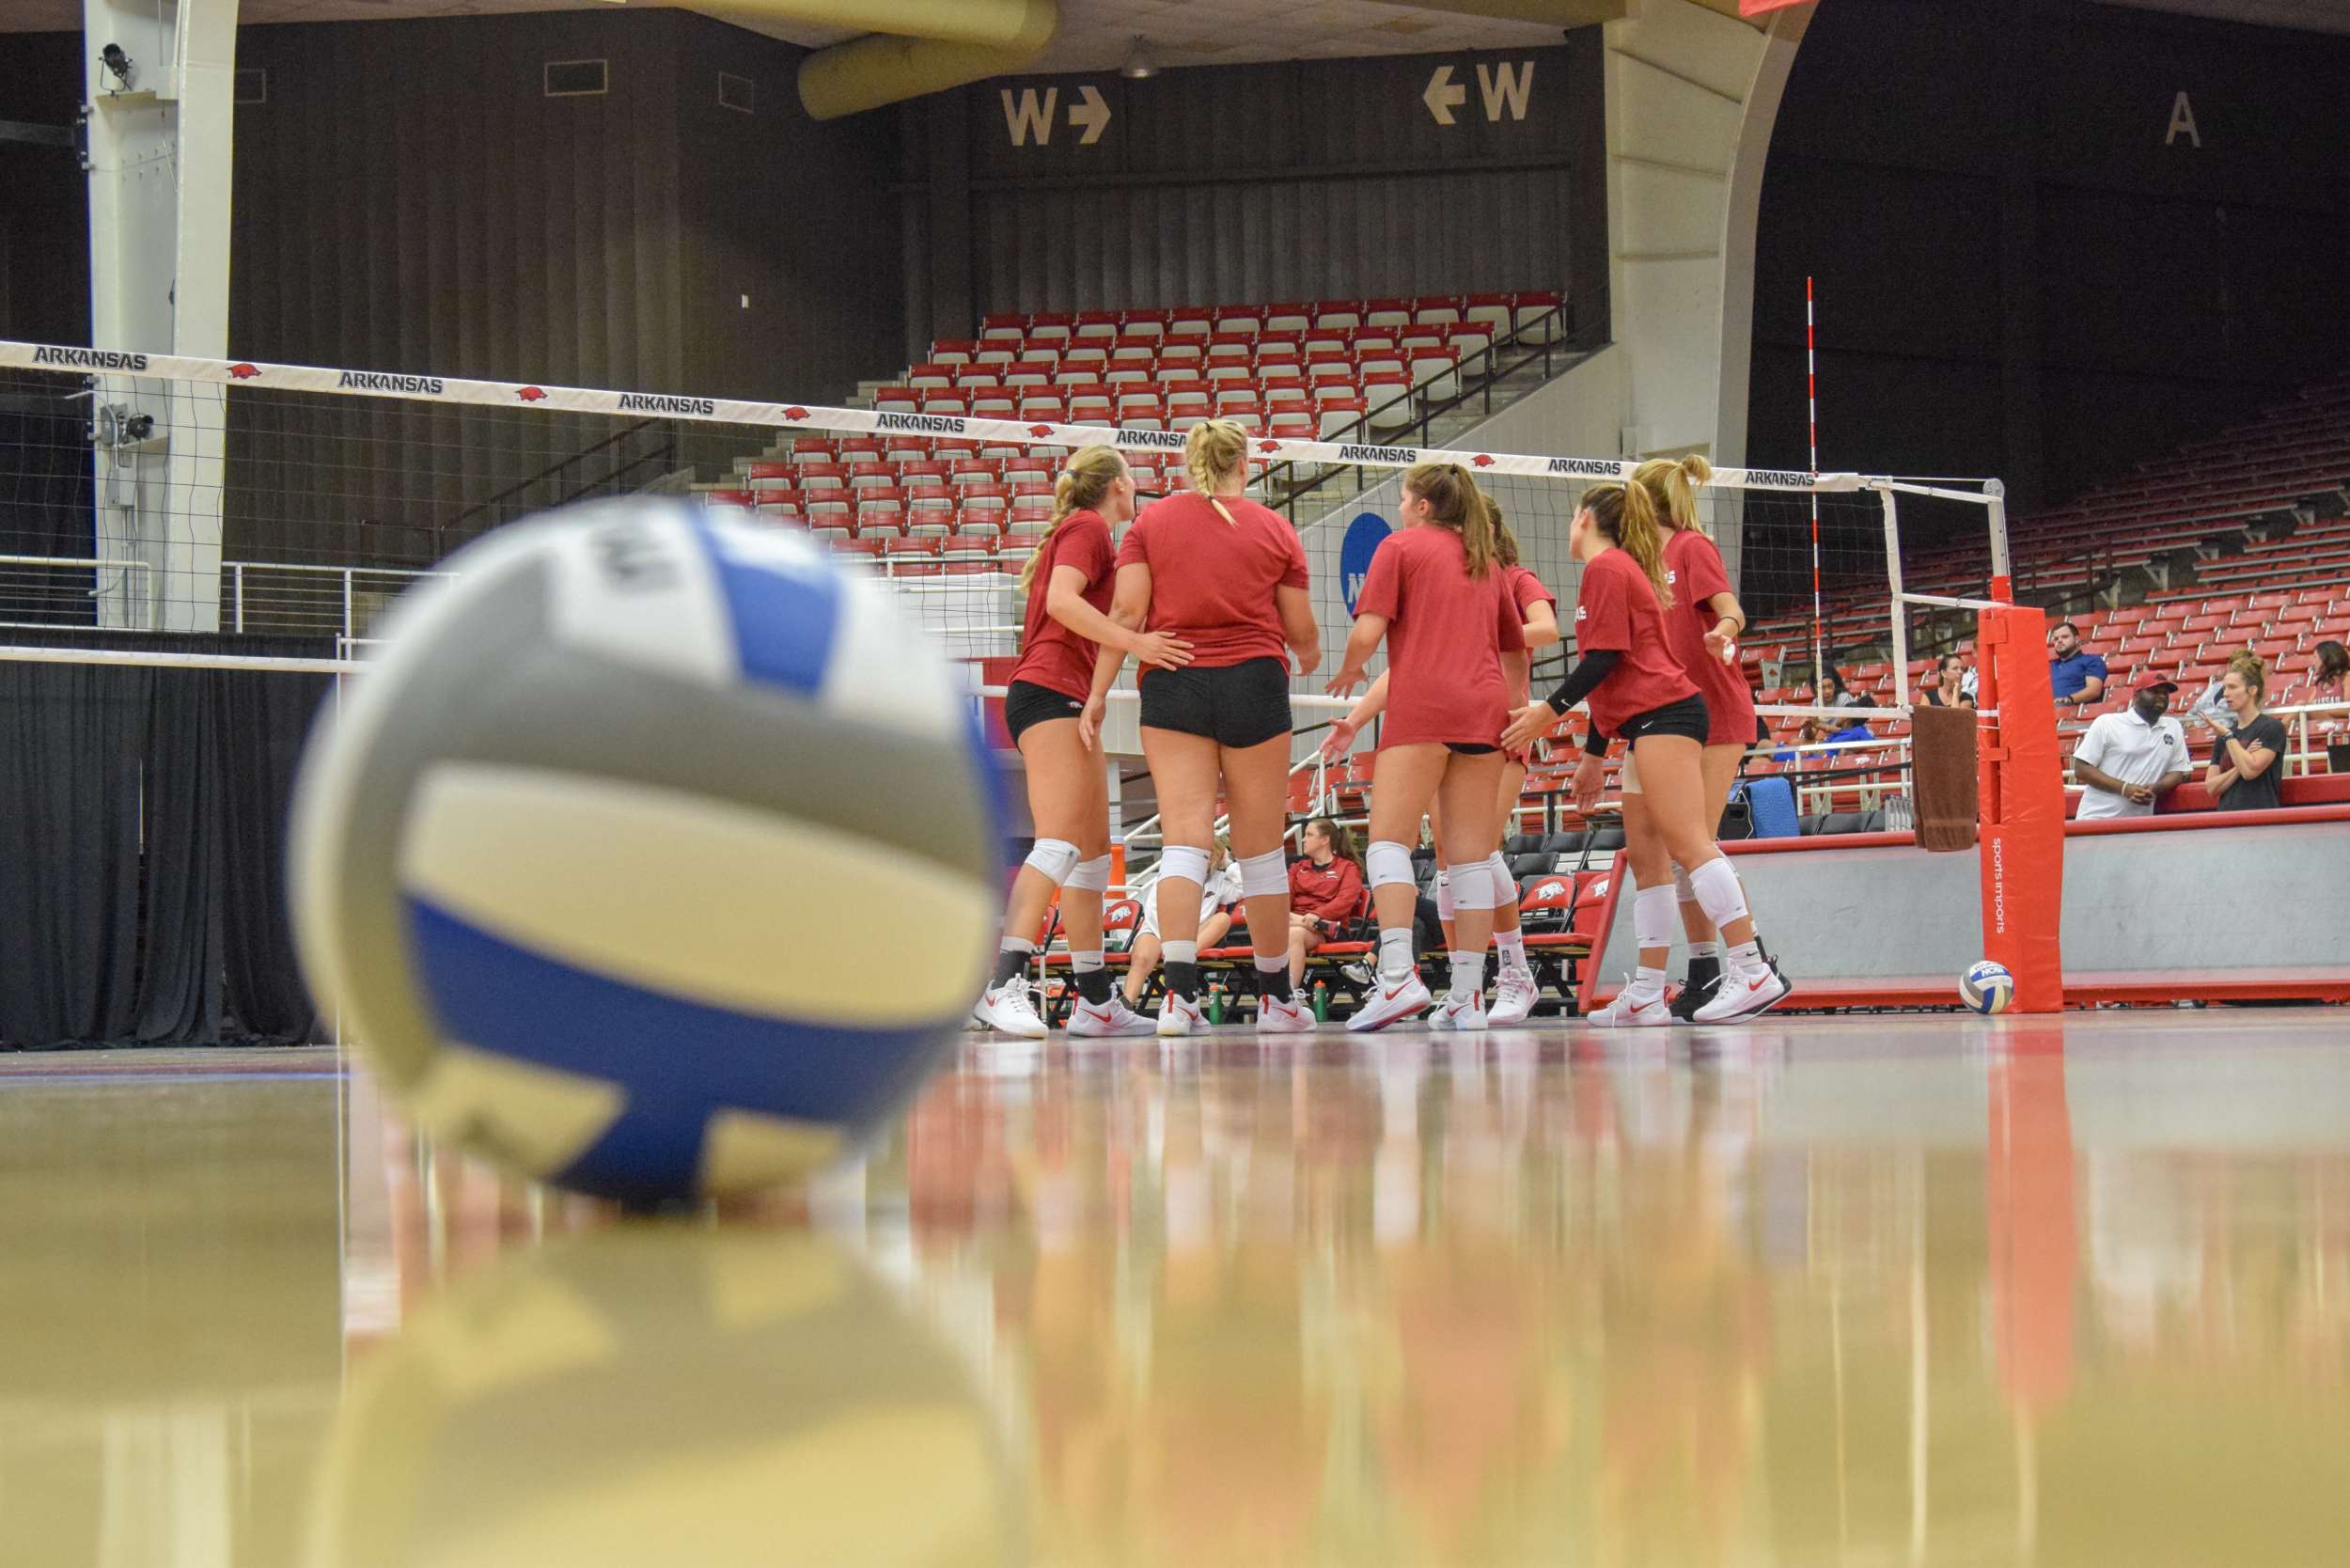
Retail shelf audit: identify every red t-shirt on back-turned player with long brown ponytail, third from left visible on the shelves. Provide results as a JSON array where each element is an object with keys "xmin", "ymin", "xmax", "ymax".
[{"xmin": 1354, "ymin": 525, "xmax": 1526, "ymax": 750}]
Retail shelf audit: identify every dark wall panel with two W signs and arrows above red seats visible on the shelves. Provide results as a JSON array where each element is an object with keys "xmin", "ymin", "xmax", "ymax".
[{"xmin": 901, "ymin": 28, "xmax": 1606, "ymax": 351}]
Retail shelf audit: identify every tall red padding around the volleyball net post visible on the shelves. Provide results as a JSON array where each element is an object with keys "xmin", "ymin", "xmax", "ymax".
[{"xmin": 1977, "ymin": 604, "xmax": 2063, "ymax": 1013}]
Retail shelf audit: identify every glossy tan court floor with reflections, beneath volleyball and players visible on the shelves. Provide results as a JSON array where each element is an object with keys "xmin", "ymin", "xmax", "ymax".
[{"xmin": 0, "ymin": 1011, "xmax": 2350, "ymax": 1568}]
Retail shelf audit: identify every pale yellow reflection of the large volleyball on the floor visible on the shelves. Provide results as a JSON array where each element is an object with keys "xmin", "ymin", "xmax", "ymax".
[{"xmin": 304, "ymin": 1225, "xmax": 1029, "ymax": 1568}]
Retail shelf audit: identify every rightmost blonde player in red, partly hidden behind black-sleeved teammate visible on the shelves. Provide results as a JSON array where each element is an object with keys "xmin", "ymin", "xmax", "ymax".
[{"xmin": 1624, "ymin": 454, "xmax": 1756, "ymax": 1020}]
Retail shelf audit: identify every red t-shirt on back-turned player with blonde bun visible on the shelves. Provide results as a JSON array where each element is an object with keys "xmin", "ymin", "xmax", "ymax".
[{"xmin": 1119, "ymin": 492, "xmax": 1307, "ymax": 670}]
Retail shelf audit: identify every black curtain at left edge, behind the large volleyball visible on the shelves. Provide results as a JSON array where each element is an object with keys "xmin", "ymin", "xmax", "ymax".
[{"xmin": 0, "ymin": 633, "xmax": 332, "ymax": 1046}]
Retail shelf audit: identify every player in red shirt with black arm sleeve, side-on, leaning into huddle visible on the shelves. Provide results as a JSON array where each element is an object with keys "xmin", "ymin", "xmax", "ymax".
[{"xmin": 1504, "ymin": 484, "xmax": 1789, "ymax": 1027}]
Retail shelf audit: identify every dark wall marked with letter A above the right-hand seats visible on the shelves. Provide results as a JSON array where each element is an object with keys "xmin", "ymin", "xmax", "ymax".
[{"xmin": 1748, "ymin": 0, "xmax": 2350, "ymax": 526}]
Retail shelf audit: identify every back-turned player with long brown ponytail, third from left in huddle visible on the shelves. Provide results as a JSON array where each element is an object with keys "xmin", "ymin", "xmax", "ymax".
[{"xmin": 1330, "ymin": 463, "xmax": 1526, "ymax": 1029}]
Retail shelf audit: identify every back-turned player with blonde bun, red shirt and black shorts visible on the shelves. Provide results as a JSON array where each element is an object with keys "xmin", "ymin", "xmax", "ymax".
[{"xmin": 1079, "ymin": 418, "xmax": 1321, "ymax": 1034}]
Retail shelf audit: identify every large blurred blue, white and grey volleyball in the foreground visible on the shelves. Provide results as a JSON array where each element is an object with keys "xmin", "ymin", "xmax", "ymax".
[{"xmin": 294, "ymin": 498, "xmax": 1004, "ymax": 1203}]
